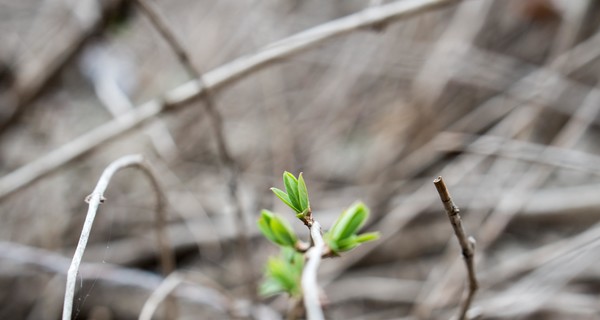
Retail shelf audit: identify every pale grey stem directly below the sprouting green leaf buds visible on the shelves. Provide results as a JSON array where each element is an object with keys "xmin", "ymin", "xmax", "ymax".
[{"xmin": 302, "ymin": 221, "xmax": 325, "ymax": 320}]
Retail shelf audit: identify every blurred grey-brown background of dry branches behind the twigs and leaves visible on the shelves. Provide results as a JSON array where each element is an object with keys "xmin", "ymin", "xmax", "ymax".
[{"xmin": 0, "ymin": 0, "xmax": 600, "ymax": 319}]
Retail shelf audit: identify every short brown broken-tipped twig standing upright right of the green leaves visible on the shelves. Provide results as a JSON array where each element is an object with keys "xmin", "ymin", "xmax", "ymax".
[{"xmin": 433, "ymin": 176, "xmax": 479, "ymax": 320}]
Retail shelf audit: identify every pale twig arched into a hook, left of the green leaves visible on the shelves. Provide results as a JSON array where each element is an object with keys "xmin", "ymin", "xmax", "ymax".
[{"xmin": 62, "ymin": 155, "xmax": 175, "ymax": 320}]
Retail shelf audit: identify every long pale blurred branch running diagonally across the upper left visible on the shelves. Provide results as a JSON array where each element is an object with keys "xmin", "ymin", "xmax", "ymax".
[{"xmin": 0, "ymin": 0, "xmax": 457, "ymax": 200}]
